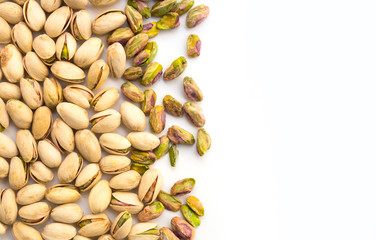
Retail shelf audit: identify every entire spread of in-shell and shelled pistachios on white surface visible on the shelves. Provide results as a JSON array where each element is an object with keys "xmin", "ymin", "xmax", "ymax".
[{"xmin": 0, "ymin": 0, "xmax": 211, "ymax": 240}]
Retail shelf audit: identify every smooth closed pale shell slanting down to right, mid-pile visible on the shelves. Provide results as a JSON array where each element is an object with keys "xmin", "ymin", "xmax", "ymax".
[{"xmin": 56, "ymin": 102, "xmax": 89, "ymax": 130}]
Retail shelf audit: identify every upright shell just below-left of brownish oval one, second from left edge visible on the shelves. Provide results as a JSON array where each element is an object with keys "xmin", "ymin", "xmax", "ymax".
[{"xmin": 16, "ymin": 130, "xmax": 38, "ymax": 162}]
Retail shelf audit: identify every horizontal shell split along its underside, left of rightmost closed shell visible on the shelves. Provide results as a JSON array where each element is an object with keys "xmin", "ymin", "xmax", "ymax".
[{"xmin": 99, "ymin": 133, "xmax": 131, "ymax": 155}]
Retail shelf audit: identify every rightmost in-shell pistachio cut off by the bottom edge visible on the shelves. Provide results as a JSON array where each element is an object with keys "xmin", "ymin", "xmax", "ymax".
[{"xmin": 128, "ymin": 222, "xmax": 159, "ymax": 240}]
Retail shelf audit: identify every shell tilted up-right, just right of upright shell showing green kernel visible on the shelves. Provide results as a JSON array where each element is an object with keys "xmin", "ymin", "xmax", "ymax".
[{"xmin": 73, "ymin": 37, "xmax": 104, "ymax": 68}]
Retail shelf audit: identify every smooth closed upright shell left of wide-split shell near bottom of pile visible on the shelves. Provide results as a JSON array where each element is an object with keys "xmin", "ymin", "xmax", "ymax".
[{"xmin": 88, "ymin": 180, "xmax": 112, "ymax": 214}]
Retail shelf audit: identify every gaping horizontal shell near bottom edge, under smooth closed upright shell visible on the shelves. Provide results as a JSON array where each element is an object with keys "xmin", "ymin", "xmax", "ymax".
[{"xmin": 77, "ymin": 213, "xmax": 111, "ymax": 237}]
